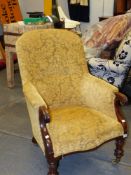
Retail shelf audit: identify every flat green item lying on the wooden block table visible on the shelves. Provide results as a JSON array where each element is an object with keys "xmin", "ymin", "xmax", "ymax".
[{"xmin": 24, "ymin": 17, "xmax": 49, "ymax": 24}]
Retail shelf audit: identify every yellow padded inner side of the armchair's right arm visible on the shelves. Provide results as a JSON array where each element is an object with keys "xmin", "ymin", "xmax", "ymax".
[{"xmin": 81, "ymin": 74, "xmax": 118, "ymax": 118}]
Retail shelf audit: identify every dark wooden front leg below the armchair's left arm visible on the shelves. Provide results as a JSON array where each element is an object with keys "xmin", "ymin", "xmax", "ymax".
[{"xmin": 47, "ymin": 158, "xmax": 59, "ymax": 175}]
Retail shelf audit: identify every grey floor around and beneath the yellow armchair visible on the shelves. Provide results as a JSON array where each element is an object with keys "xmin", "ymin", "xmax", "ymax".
[{"xmin": 0, "ymin": 70, "xmax": 131, "ymax": 175}]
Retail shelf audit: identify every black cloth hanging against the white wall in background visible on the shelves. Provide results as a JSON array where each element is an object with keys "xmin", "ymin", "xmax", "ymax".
[{"xmin": 68, "ymin": 0, "xmax": 90, "ymax": 22}]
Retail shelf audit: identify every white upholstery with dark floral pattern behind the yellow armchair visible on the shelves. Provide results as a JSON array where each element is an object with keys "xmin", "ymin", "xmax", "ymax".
[{"xmin": 88, "ymin": 31, "xmax": 131, "ymax": 88}]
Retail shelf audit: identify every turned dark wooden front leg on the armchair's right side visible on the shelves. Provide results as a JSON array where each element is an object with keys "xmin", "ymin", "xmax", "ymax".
[{"xmin": 113, "ymin": 137, "xmax": 125, "ymax": 164}]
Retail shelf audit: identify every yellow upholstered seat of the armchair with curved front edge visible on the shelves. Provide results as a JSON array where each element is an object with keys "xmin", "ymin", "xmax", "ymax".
[{"xmin": 47, "ymin": 106, "xmax": 123, "ymax": 157}]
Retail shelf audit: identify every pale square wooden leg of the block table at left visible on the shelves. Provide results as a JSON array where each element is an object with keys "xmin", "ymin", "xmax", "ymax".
[{"xmin": 6, "ymin": 52, "xmax": 14, "ymax": 88}]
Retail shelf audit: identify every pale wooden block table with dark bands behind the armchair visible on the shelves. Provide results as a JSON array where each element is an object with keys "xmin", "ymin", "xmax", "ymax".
[{"xmin": 4, "ymin": 22, "xmax": 53, "ymax": 88}]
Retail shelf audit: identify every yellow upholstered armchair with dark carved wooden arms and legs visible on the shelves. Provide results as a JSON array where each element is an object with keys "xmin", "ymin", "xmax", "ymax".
[{"xmin": 16, "ymin": 29, "xmax": 127, "ymax": 175}]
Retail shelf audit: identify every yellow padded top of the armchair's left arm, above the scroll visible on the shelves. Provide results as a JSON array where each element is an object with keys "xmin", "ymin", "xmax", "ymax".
[{"xmin": 23, "ymin": 82, "xmax": 47, "ymax": 108}]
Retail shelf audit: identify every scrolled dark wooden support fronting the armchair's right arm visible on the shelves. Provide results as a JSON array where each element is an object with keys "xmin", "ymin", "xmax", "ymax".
[{"xmin": 115, "ymin": 92, "xmax": 128, "ymax": 137}]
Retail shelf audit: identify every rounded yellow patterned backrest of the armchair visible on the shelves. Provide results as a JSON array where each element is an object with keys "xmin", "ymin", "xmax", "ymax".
[{"xmin": 16, "ymin": 29, "xmax": 87, "ymax": 106}]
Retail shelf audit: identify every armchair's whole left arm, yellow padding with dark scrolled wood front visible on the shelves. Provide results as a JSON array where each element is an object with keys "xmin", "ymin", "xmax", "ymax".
[{"xmin": 23, "ymin": 82, "xmax": 51, "ymax": 153}]
